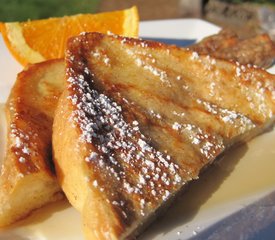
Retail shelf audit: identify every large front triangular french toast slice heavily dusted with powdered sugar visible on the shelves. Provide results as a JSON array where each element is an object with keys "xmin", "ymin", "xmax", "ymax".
[{"xmin": 53, "ymin": 33, "xmax": 275, "ymax": 240}]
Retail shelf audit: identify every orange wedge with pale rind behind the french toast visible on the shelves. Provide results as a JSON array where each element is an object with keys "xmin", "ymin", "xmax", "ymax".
[{"xmin": 0, "ymin": 7, "xmax": 139, "ymax": 65}]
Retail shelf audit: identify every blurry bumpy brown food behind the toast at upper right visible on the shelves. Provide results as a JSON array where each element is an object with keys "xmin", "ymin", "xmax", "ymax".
[{"xmin": 190, "ymin": 29, "xmax": 275, "ymax": 68}]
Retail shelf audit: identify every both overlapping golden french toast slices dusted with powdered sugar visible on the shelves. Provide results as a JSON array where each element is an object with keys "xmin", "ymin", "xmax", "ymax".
[{"xmin": 0, "ymin": 27, "xmax": 275, "ymax": 239}]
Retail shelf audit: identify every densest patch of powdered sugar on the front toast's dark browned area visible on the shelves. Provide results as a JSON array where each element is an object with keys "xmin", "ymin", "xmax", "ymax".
[{"xmin": 67, "ymin": 56, "xmax": 182, "ymax": 214}]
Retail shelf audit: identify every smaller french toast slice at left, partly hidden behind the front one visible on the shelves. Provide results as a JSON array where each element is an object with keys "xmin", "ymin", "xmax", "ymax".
[{"xmin": 0, "ymin": 60, "xmax": 65, "ymax": 227}]
